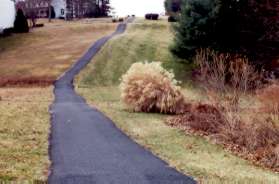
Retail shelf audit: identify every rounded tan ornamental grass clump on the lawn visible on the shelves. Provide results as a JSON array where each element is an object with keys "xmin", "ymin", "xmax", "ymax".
[{"xmin": 120, "ymin": 62, "xmax": 186, "ymax": 114}]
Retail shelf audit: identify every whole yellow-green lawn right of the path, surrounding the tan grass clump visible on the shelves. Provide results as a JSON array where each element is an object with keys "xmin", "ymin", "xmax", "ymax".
[{"xmin": 76, "ymin": 20, "xmax": 279, "ymax": 183}]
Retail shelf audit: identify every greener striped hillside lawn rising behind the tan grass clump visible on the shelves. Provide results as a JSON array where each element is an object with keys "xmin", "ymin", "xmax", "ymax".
[{"xmin": 76, "ymin": 18, "xmax": 195, "ymax": 86}]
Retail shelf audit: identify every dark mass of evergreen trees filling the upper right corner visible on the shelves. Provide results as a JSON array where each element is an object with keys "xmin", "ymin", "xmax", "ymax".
[{"xmin": 171, "ymin": 0, "xmax": 279, "ymax": 67}]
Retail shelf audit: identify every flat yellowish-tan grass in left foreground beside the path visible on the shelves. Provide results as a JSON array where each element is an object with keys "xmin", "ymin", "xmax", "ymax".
[{"xmin": 0, "ymin": 88, "xmax": 53, "ymax": 183}]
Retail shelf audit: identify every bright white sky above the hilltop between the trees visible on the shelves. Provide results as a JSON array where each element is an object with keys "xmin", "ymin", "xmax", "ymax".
[{"xmin": 111, "ymin": 0, "xmax": 165, "ymax": 16}]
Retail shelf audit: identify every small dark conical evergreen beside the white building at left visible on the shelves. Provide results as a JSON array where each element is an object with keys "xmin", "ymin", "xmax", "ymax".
[{"xmin": 14, "ymin": 9, "xmax": 29, "ymax": 33}]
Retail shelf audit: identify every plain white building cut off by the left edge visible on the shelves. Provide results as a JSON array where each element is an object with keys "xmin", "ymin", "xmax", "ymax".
[{"xmin": 0, "ymin": 0, "xmax": 16, "ymax": 33}]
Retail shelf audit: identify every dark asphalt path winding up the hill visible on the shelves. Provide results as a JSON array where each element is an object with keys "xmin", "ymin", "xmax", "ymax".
[{"xmin": 48, "ymin": 19, "xmax": 195, "ymax": 184}]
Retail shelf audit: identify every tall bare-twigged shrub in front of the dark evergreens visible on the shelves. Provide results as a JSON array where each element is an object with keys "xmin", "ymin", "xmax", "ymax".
[{"xmin": 195, "ymin": 49, "xmax": 263, "ymax": 111}]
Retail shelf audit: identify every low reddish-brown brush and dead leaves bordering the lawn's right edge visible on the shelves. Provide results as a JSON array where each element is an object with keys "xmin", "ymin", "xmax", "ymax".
[{"xmin": 167, "ymin": 104, "xmax": 279, "ymax": 171}]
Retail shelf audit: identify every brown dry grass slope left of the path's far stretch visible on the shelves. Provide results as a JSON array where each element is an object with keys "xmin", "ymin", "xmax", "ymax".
[{"xmin": 0, "ymin": 19, "xmax": 117, "ymax": 86}]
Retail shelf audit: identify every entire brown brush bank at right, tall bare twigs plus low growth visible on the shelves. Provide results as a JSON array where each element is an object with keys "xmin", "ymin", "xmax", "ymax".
[{"xmin": 168, "ymin": 50, "xmax": 279, "ymax": 171}]
